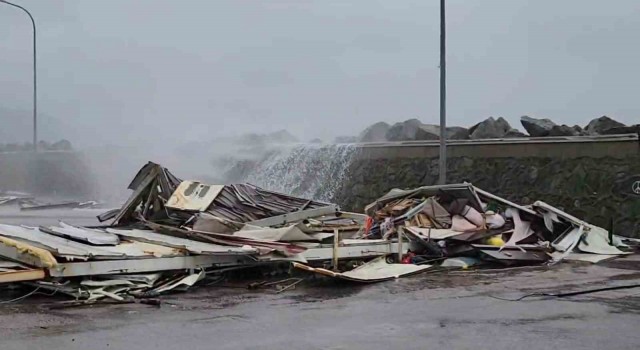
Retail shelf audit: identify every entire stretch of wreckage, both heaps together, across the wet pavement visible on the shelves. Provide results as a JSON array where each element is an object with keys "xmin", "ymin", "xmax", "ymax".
[{"xmin": 0, "ymin": 162, "xmax": 637, "ymax": 303}]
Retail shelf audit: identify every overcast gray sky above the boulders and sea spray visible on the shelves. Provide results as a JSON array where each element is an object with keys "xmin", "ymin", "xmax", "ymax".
[{"xmin": 0, "ymin": 0, "xmax": 640, "ymax": 145}]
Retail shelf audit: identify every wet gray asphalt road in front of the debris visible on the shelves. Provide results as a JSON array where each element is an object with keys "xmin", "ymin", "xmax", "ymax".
[{"xmin": 0, "ymin": 209, "xmax": 640, "ymax": 350}]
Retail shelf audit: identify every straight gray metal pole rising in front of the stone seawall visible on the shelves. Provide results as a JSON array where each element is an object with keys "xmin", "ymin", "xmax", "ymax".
[{"xmin": 438, "ymin": 0, "xmax": 447, "ymax": 185}]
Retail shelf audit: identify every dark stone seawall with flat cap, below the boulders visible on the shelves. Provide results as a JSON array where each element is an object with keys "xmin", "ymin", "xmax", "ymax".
[{"xmin": 333, "ymin": 136, "xmax": 640, "ymax": 237}]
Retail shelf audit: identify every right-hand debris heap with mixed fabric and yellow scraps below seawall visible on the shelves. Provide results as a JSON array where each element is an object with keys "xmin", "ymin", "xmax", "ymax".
[{"xmin": 356, "ymin": 183, "xmax": 630, "ymax": 266}]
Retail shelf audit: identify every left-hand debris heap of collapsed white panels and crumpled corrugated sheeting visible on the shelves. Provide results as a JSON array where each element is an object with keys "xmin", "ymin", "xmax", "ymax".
[{"xmin": 0, "ymin": 163, "xmax": 397, "ymax": 301}]
